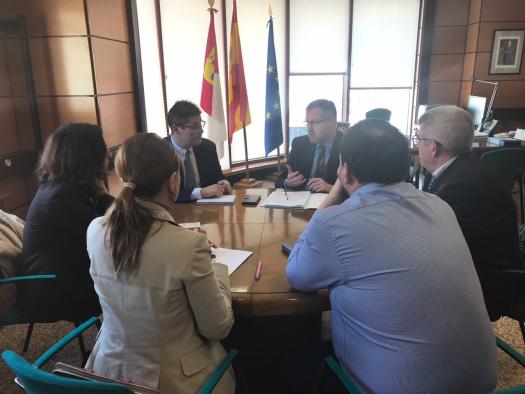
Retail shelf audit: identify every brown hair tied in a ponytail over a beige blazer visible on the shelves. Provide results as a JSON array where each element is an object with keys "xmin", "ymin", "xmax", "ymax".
[{"xmin": 105, "ymin": 133, "xmax": 179, "ymax": 278}]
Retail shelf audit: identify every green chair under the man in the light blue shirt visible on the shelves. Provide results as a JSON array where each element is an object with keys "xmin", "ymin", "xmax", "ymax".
[{"xmin": 314, "ymin": 337, "xmax": 525, "ymax": 394}]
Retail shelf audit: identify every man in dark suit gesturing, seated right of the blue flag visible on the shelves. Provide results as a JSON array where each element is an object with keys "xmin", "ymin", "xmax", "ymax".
[{"xmin": 275, "ymin": 99, "xmax": 342, "ymax": 193}]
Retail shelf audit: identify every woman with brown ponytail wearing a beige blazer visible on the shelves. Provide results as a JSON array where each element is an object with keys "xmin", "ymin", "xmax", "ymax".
[{"xmin": 86, "ymin": 133, "xmax": 235, "ymax": 393}]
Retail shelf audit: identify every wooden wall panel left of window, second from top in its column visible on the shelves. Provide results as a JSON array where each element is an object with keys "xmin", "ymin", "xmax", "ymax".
[{"xmin": 91, "ymin": 38, "xmax": 133, "ymax": 94}]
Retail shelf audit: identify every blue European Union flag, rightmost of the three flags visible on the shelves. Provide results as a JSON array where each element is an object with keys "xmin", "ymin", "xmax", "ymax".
[{"xmin": 264, "ymin": 17, "xmax": 283, "ymax": 156}]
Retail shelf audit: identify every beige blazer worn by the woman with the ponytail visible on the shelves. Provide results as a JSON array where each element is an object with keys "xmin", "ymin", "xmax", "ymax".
[{"xmin": 86, "ymin": 202, "xmax": 235, "ymax": 393}]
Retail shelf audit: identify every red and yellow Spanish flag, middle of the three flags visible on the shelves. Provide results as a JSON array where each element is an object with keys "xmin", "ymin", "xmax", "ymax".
[{"xmin": 228, "ymin": 0, "xmax": 252, "ymax": 142}]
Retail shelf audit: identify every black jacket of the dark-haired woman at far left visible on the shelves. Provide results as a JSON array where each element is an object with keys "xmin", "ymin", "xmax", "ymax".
[{"xmin": 19, "ymin": 183, "xmax": 113, "ymax": 322}]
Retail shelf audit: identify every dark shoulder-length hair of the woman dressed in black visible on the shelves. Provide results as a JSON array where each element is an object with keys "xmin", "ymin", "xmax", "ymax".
[{"xmin": 36, "ymin": 123, "xmax": 108, "ymax": 191}]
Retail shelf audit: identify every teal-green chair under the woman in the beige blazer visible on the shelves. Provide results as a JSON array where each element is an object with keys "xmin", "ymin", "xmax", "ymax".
[{"xmin": 2, "ymin": 317, "xmax": 238, "ymax": 394}]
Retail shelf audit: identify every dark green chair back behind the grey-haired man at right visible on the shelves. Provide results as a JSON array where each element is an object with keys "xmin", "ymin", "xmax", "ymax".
[{"xmin": 479, "ymin": 148, "xmax": 525, "ymax": 224}]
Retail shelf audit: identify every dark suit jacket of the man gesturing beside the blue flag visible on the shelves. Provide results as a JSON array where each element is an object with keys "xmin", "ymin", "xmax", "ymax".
[{"xmin": 275, "ymin": 132, "xmax": 343, "ymax": 188}]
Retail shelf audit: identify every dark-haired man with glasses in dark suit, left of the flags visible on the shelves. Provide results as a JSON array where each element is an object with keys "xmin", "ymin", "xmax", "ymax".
[{"xmin": 166, "ymin": 100, "xmax": 231, "ymax": 202}]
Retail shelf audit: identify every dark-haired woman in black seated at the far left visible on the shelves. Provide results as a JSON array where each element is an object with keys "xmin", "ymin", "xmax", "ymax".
[{"xmin": 21, "ymin": 123, "xmax": 113, "ymax": 323}]
